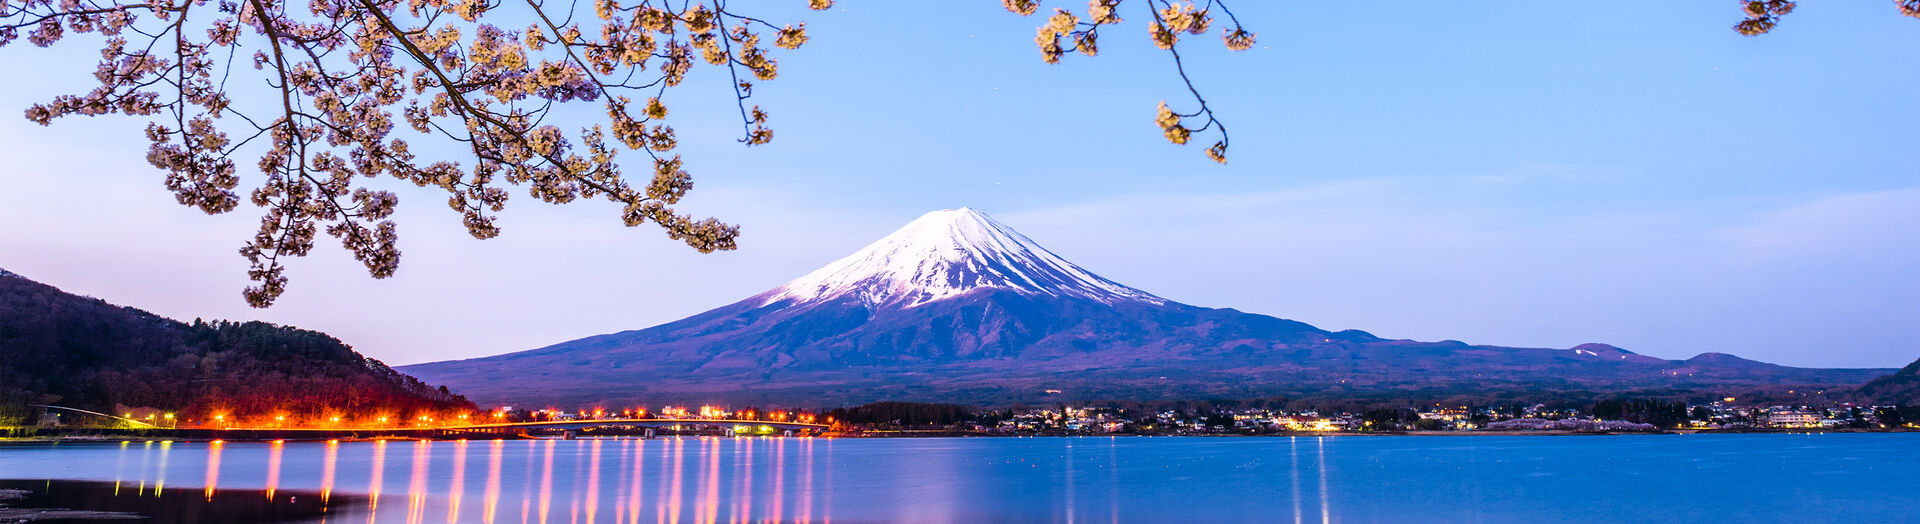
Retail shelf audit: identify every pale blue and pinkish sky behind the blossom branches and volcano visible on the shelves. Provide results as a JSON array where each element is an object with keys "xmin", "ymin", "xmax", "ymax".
[{"xmin": 0, "ymin": 0, "xmax": 1920, "ymax": 367}]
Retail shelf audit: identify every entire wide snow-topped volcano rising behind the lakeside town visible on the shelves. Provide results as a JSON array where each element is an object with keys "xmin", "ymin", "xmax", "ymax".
[{"xmin": 401, "ymin": 207, "xmax": 1891, "ymax": 407}]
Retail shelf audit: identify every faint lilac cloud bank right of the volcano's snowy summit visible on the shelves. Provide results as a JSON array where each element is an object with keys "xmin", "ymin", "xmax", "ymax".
[{"xmin": 1004, "ymin": 177, "xmax": 1920, "ymax": 367}]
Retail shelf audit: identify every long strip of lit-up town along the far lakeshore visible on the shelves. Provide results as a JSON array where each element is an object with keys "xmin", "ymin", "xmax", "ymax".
[{"xmin": 6, "ymin": 397, "xmax": 1920, "ymax": 440}]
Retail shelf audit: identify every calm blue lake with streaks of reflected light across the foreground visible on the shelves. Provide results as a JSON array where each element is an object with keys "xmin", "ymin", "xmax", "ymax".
[{"xmin": 0, "ymin": 434, "xmax": 1920, "ymax": 522}]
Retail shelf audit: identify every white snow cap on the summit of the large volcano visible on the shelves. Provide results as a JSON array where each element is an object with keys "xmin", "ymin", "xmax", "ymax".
[{"xmin": 764, "ymin": 207, "xmax": 1165, "ymax": 307}]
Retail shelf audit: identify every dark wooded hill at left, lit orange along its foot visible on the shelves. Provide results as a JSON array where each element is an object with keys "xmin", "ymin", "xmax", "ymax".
[{"xmin": 0, "ymin": 264, "xmax": 472, "ymax": 424}]
